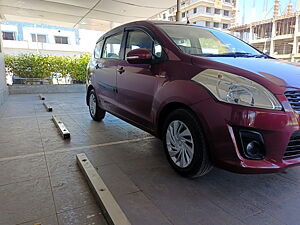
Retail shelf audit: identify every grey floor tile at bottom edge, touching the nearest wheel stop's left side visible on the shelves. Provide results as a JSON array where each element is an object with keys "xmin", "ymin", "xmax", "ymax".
[{"xmin": 58, "ymin": 204, "xmax": 107, "ymax": 225}]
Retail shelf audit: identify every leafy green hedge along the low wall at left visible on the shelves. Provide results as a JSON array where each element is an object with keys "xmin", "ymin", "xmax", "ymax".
[{"xmin": 5, "ymin": 53, "xmax": 91, "ymax": 82}]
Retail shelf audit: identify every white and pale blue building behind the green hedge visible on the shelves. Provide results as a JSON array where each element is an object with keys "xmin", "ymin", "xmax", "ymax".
[{"xmin": 1, "ymin": 21, "xmax": 103, "ymax": 55}]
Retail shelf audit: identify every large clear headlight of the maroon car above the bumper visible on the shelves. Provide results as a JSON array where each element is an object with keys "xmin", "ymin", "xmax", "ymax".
[{"xmin": 192, "ymin": 69, "xmax": 282, "ymax": 110}]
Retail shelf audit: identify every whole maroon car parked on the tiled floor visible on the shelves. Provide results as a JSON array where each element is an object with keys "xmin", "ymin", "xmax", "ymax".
[{"xmin": 87, "ymin": 21, "xmax": 300, "ymax": 177}]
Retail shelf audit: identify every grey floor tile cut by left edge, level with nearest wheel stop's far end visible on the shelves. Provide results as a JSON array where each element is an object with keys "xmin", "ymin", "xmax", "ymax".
[{"xmin": 0, "ymin": 156, "xmax": 48, "ymax": 185}]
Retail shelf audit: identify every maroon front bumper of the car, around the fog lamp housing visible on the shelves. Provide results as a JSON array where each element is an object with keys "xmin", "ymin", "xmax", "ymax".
[{"xmin": 191, "ymin": 95, "xmax": 300, "ymax": 173}]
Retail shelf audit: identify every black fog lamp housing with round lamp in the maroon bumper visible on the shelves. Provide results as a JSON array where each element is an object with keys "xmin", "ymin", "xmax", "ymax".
[{"xmin": 239, "ymin": 130, "xmax": 265, "ymax": 160}]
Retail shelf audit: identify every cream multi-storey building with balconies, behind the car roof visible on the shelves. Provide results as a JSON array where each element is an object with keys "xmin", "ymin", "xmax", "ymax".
[{"xmin": 150, "ymin": 0, "xmax": 238, "ymax": 30}]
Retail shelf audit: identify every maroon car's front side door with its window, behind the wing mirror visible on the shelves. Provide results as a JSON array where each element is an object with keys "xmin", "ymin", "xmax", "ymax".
[{"xmin": 117, "ymin": 29, "xmax": 162, "ymax": 127}]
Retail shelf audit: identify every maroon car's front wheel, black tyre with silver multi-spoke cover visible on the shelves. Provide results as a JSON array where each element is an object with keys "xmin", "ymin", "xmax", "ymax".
[{"xmin": 163, "ymin": 109, "xmax": 213, "ymax": 178}]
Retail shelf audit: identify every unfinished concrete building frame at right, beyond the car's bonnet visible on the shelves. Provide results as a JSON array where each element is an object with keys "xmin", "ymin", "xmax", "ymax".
[{"xmin": 229, "ymin": 0, "xmax": 300, "ymax": 62}]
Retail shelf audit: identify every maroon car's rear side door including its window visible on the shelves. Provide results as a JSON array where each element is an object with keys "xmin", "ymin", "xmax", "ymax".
[{"xmin": 95, "ymin": 32, "xmax": 123, "ymax": 111}]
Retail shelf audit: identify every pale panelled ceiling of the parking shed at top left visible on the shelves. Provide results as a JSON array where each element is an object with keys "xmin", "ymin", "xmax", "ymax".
[{"xmin": 0, "ymin": 0, "xmax": 176, "ymax": 31}]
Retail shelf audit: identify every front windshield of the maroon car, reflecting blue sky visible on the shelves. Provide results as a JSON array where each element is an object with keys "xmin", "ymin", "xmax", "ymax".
[{"xmin": 159, "ymin": 24, "xmax": 265, "ymax": 57}]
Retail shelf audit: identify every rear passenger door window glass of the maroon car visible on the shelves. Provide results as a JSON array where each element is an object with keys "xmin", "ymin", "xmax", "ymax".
[{"xmin": 102, "ymin": 33, "xmax": 123, "ymax": 59}]
